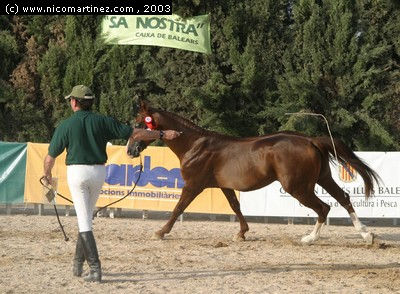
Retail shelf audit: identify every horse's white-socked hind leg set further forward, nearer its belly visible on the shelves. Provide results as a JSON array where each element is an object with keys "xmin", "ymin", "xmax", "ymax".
[{"xmin": 293, "ymin": 191, "xmax": 331, "ymax": 245}]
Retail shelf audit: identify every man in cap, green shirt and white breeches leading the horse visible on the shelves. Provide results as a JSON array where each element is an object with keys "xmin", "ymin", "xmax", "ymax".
[{"xmin": 44, "ymin": 85, "xmax": 179, "ymax": 282}]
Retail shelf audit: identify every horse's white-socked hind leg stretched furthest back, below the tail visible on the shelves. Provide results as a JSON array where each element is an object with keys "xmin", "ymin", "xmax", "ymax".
[{"xmin": 318, "ymin": 175, "xmax": 374, "ymax": 244}]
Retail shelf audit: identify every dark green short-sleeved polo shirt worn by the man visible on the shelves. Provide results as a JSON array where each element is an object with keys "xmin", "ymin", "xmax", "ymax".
[{"xmin": 49, "ymin": 110, "xmax": 133, "ymax": 165}]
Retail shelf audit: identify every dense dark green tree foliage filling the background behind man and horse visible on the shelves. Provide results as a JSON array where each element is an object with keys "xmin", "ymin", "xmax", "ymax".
[{"xmin": 0, "ymin": 0, "xmax": 400, "ymax": 150}]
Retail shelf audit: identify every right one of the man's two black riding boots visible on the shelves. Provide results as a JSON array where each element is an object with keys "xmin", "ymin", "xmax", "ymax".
[{"xmin": 79, "ymin": 231, "xmax": 101, "ymax": 282}]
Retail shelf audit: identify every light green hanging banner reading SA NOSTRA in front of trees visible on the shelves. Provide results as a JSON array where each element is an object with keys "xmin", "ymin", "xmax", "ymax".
[{"xmin": 102, "ymin": 14, "xmax": 211, "ymax": 54}]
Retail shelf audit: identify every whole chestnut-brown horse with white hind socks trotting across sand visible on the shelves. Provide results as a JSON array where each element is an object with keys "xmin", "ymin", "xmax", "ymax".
[{"xmin": 127, "ymin": 102, "xmax": 380, "ymax": 244}]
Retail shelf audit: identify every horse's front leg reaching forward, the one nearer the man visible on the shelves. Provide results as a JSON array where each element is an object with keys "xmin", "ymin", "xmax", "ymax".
[{"xmin": 152, "ymin": 186, "xmax": 202, "ymax": 240}]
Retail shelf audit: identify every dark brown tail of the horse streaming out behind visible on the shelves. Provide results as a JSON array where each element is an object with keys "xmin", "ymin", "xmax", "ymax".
[{"xmin": 312, "ymin": 137, "xmax": 382, "ymax": 198}]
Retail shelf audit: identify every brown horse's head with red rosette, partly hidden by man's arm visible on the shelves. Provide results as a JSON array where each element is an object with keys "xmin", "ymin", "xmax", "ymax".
[{"xmin": 127, "ymin": 101, "xmax": 160, "ymax": 157}]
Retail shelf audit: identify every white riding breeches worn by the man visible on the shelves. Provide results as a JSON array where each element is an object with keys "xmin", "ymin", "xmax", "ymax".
[{"xmin": 67, "ymin": 164, "xmax": 106, "ymax": 232}]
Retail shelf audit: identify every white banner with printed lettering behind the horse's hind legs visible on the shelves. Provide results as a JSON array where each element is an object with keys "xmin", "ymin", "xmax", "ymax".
[{"xmin": 240, "ymin": 152, "xmax": 400, "ymax": 218}]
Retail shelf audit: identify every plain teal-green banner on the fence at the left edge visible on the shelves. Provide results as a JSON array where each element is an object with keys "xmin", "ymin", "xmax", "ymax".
[{"xmin": 0, "ymin": 142, "xmax": 27, "ymax": 204}]
